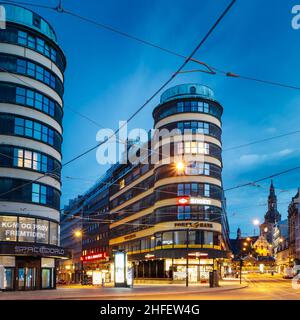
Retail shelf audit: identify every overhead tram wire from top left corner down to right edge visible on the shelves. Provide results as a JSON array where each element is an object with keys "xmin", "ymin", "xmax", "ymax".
[{"xmin": 9, "ymin": 0, "xmax": 300, "ymax": 90}]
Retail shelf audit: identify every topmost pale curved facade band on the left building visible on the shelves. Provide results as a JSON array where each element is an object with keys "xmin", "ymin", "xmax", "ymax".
[{"xmin": 0, "ymin": 43, "xmax": 64, "ymax": 83}]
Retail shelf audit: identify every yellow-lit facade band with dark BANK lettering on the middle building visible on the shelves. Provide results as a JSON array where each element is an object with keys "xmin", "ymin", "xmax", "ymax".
[{"xmin": 109, "ymin": 220, "xmax": 222, "ymax": 245}]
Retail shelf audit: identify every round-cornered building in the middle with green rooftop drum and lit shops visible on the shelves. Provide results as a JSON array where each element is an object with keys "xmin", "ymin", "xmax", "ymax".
[{"xmin": 110, "ymin": 84, "xmax": 230, "ymax": 282}]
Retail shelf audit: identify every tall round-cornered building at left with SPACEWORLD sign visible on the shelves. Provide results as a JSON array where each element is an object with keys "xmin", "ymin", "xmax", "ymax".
[{"xmin": 0, "ymin": 2, "xmax": 66, "ymax": 290}]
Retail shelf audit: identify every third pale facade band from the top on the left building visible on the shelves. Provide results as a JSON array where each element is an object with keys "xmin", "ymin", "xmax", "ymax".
[{"xmin": 0, "ymin": 103, "xmax": 63, "ymax": 135}]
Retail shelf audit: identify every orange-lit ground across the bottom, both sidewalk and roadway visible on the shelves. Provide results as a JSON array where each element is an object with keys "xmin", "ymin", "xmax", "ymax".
[{"xmin": 0, "ymin": 274, "xmax": 300, "ymax": 300}]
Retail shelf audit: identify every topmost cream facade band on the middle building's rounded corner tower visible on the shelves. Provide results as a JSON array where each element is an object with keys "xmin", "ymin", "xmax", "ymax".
[{"xmin": 155, "ymin": 113, "xmax": 222, "ymax": 129}]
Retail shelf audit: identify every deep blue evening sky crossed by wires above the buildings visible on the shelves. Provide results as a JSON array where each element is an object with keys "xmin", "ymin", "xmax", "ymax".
[{"xmin": 19, "ymin": 0, "xmax": 300, "ymax": 237}]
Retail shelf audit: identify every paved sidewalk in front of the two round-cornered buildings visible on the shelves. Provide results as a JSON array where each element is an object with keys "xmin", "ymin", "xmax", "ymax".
[{"xmin": 0, "ymin": 281, "xmax": 248, "ymax": 300}]
